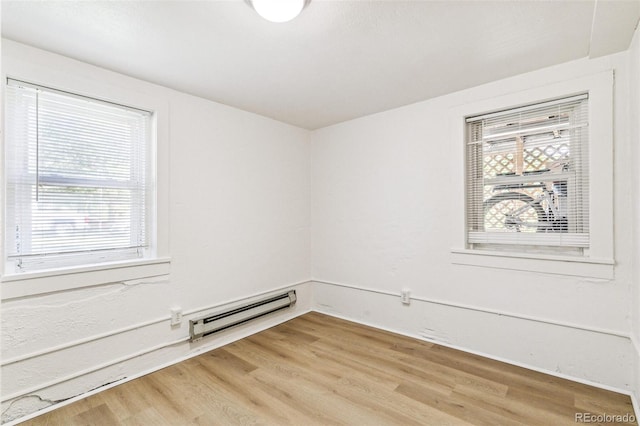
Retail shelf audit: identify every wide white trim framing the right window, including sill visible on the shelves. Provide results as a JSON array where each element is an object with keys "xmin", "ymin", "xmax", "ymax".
[{"xmin": 449, "ymin": 70, "xmax": 615, "ymax": 279}]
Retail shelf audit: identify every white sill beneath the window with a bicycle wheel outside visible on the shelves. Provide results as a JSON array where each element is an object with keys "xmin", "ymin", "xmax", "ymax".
[{"xmin": 451, "ymin": 249, "xmax": 615, "ymax": 280}]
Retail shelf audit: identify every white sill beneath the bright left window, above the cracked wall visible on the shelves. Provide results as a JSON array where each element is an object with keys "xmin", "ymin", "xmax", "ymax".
[{"xmin": 1, "ymin": 257, "xmax": 171, "ymax": 300}]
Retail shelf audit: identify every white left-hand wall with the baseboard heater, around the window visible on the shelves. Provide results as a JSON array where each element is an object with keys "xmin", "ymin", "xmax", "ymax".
[{"xmin": 1, "ymin": 40, "xmax": 311, "ymax": 421}]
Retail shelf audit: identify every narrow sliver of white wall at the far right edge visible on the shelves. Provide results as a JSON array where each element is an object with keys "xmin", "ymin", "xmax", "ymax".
[{"xmin": 629, "ymin": 23, "xmax": 640, "ymax": 410}]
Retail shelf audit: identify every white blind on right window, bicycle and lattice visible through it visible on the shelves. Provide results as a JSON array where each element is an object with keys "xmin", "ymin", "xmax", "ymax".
[{"xmin": 466, "ymin": 94, "xmax": 589, "ymax": 253}]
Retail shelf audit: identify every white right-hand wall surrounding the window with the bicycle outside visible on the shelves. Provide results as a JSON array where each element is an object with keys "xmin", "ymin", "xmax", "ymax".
[{"xmin": 311, "ymin": 53, "xmax": 637, "ymax": 391}]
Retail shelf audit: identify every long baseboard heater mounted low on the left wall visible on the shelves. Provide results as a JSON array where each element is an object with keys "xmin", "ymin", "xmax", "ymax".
[{"xmin": 189, "ymin": 290, "xmax": 296, "ymax": 342}]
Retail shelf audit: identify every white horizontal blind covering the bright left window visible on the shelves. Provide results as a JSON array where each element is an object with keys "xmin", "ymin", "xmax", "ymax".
[{"xmin": 5, "ymin": 80, "xmax": 150, "ymax": 272}]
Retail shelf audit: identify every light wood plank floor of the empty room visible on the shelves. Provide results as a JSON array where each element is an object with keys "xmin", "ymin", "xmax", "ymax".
[{"xmin": 20, "ymin": 313, "xmax": 637, "ymax": 426}]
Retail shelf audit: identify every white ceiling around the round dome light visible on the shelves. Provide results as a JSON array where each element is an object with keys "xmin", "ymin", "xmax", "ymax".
[{"xmin": 1, "ymin": 0, "xmax": 640, "ymax": 129}]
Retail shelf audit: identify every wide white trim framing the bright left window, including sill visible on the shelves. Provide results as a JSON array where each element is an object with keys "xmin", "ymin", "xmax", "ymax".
[{"xmin": 0, "ymin": 64, "xmax": 171, "ymax": 300}]
